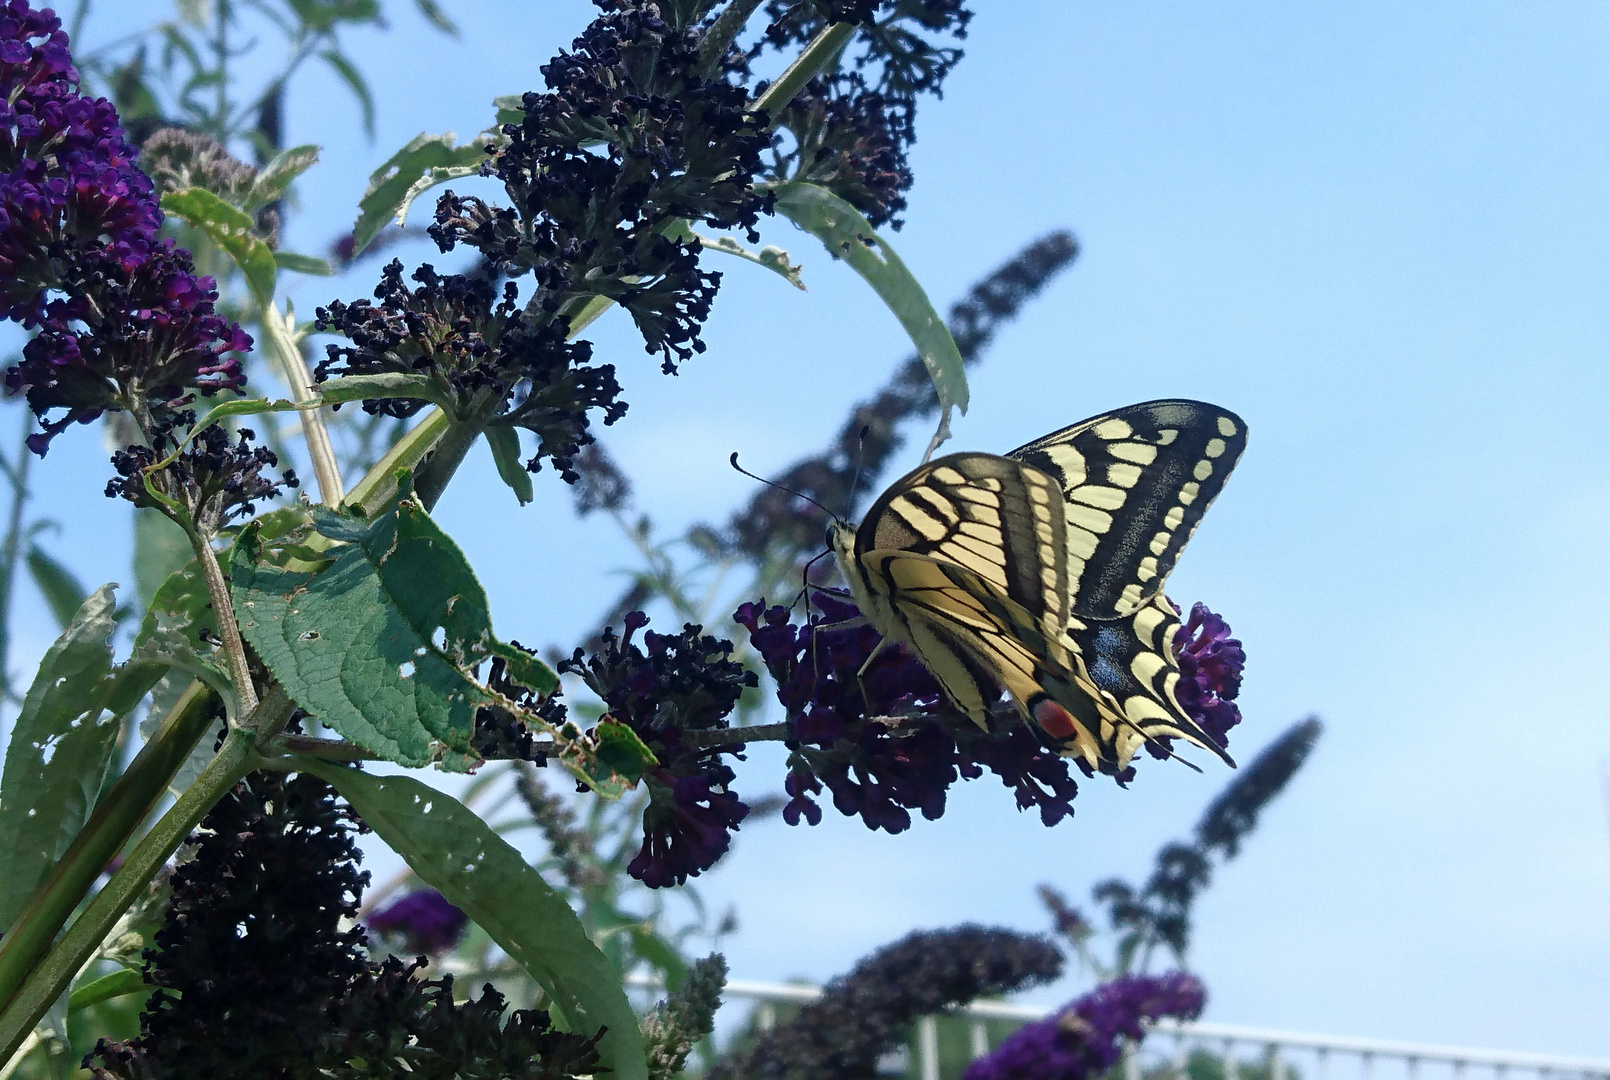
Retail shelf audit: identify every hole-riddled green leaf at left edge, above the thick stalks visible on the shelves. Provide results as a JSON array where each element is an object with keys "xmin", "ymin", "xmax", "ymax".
[{"xmin": 0, "ymin": 584, "xmax": 164, "ymax": 927}]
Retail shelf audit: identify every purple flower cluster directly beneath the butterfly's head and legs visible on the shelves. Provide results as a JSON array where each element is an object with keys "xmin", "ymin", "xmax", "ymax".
[{"xmin": 733, "ymin": 592, "xmax": 1079, "ymax": 832}]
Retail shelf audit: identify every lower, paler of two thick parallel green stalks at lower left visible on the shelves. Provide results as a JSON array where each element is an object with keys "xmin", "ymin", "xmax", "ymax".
[{"xmin": 0, "ymin": 729, "xmax": 258, "ymax": 1061}]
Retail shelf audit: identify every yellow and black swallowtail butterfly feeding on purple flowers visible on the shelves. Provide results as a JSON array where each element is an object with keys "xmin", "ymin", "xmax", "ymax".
[{"xmin": 828, "ymin": 401, "xmax": 1246, "ymax": 773}]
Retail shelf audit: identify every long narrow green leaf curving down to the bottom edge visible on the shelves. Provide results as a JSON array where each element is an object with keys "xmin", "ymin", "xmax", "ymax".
[{"xmin": 299, "ymin": 761, "xmax": 647, "ymax": 1080}]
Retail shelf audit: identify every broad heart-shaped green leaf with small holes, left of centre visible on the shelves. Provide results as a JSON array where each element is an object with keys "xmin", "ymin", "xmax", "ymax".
[{"xmin": 230, "ymin": 484, "xmax": 559, "ymax": 766}]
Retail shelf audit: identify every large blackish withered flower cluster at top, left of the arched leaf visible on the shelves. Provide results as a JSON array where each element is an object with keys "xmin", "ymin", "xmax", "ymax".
[{"xmin": 430, "ymin": 2, "xmax": 774, "ymax": 373}]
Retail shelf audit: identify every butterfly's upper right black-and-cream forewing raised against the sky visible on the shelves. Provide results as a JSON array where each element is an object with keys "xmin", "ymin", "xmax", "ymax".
[{"xmin": 1006, "ymin": 401, "xmax": 1246, "ymax": 620}]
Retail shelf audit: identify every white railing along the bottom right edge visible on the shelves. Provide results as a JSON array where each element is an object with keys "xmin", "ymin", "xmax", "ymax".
[{"xmin": 630, "ymin": 977, "xmax": 1610, "ymax": 1080}]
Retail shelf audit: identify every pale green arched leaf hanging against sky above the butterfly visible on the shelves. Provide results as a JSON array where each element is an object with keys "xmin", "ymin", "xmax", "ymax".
[{"xmin": 776, "ymin": 182, "xmax": 968, "ymax": 414}]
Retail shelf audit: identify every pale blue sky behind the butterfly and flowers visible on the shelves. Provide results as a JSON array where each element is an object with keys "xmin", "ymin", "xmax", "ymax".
[{"xmin": 15, "ymin": 0, "xmax": 1610, "ymax": 1056}]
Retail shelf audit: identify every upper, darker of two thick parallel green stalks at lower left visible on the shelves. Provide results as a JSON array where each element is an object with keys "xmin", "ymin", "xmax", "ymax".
[{"xmin": 0, "ymin": 681, "xmax": 219, "ymax": 1023}]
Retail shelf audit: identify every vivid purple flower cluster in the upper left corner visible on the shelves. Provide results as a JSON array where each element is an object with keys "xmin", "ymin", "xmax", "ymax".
[{"xmin": 0, "ymin": 0, "xmax": 251, "ymax": 454}]
